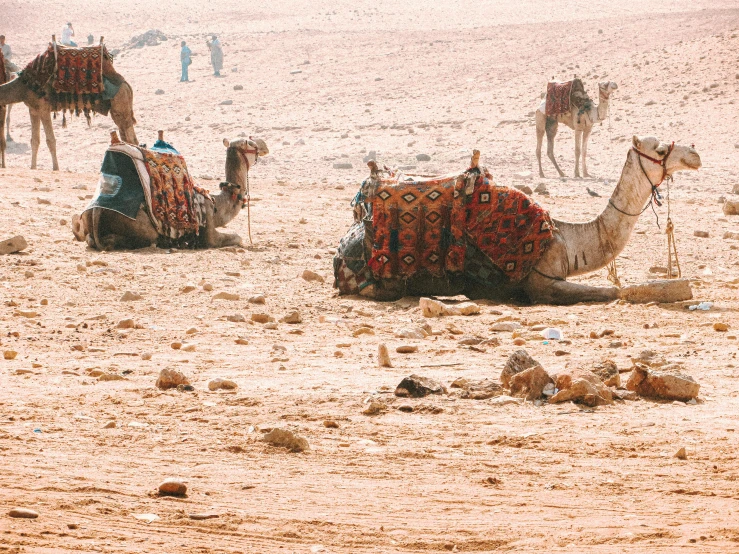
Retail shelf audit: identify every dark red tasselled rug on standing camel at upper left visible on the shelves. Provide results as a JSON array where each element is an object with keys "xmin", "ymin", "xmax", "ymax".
[{"xmin": 18, "ymin": 45, "xmax": 122, "ymax": 115}]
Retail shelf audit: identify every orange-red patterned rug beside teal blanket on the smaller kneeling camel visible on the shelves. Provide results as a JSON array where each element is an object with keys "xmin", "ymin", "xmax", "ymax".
[{"xmin": 139, "ymin": 148, "xmax": 212, "ymax": 238}]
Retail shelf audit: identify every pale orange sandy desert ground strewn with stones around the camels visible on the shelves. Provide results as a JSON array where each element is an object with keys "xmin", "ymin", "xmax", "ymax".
[{"xmin": 0, "ymin": 0, "xmax": 739, "ymax": 553}]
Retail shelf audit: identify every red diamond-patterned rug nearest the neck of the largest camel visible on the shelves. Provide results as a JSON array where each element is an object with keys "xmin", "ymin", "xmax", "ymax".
[{"xmin": 465, "ymin": 175, "xmax": 554, "ymax": 283}]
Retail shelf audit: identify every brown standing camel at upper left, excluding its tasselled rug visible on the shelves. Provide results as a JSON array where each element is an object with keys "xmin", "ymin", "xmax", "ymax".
[{"xmin": 0, "ymin": 39, "xmax": 138, "ymax": 171}]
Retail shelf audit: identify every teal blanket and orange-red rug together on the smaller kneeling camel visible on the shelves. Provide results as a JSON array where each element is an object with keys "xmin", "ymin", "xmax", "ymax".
[{"xmin": 85, "ymin": 140, "xmax": 212, "ymax": 239}]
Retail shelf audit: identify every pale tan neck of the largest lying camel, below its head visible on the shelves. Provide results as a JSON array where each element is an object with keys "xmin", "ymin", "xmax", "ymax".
[{"xmin": 555, "ymin": 150, "xmax": 652, "ymax": 276}]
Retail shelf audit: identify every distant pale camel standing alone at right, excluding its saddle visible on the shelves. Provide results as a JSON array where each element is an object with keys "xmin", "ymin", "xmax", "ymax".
[{"xmin": 536, "ymin": 81, "xmax": 618, "ymax": 179}]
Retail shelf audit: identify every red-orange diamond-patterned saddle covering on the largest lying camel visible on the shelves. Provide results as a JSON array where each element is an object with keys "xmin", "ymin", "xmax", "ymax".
[{"xmin": 347, "ymin": 164, "xmax": 554, "ymax": 283}]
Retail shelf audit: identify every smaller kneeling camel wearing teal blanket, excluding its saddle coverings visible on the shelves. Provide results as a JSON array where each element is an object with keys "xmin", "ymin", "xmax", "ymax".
[{"xmin": 72, "ymin": 131, "xmax": 269, "ymax": 250}]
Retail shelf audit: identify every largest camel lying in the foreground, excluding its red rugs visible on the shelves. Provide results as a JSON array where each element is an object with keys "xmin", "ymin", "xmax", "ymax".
[{"xmin": 334, "ymin": 136, "xmax": 701, "ymax": 305}]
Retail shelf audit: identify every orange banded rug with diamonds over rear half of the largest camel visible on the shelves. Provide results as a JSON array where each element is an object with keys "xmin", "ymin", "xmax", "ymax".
[{"xmin": 367, "ymin": 175, "xmax": 465, "ymax": 279}]
